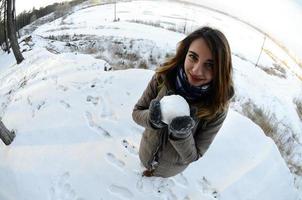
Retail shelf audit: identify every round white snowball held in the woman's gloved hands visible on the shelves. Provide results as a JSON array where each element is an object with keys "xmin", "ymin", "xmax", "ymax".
[{"xmin": 160, "ymin": 95, "xmax": 190, "ymax": 124}]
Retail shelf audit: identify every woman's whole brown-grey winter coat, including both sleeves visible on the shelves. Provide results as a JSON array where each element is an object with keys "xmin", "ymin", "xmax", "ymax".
[{"xmin": 132, "ymin": 74, "xmax": 227, "ymax": 177}]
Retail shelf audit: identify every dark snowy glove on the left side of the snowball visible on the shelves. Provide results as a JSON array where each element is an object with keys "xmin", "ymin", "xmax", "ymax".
[{"xmin": 149, "ymin": 99, "xmax": 167, "ymax": 129}]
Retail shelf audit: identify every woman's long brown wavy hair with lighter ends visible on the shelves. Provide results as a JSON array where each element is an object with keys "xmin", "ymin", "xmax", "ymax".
[{"xmin": 156, "ymin": 27, "xmax": 234, "ymax": 119}]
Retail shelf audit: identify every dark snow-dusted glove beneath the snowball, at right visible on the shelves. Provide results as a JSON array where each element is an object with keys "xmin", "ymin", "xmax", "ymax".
[{"xmin": 169, "ymin": 116, "xmax": 195, "ymax": 140}]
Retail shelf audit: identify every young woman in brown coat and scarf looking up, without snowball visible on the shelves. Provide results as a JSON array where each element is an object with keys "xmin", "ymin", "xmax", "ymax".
[{"xmin": 132, "ymin": 27, "xmax": 234, "ymax": 177}]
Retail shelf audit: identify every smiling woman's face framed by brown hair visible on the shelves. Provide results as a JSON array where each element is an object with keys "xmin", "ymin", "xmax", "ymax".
[{"xmin": 184, "ymin": 38, "xmax": 214, "ymax": 86}]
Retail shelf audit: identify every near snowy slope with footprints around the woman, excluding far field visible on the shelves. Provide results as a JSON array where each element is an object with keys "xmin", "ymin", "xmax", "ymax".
[{"xmin": 0, "ymin": 48, "xmax": 297, "ymax": 200}]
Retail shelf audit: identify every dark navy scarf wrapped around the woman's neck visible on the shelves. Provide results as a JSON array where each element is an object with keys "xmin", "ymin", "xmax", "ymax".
[{"xmin": 175, "ymin": 66, "xmax": 211, "ymax": 102}]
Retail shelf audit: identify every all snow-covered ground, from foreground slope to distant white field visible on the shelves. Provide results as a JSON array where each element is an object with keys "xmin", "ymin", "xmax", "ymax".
[{"xmin": 0, "ymin": 1, "xmax": 302, "ymax": 200}]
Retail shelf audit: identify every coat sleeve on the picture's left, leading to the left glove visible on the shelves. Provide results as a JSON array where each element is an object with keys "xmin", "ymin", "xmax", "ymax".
[{"xmin": 132, "ymin": 74, "xmax": 158, "ymax": 129}]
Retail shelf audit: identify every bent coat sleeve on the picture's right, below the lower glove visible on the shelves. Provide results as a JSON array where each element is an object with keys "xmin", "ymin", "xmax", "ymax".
[{"xmin": 170, "ymin": 111, "xmax": 227, "ymax": 164}]
